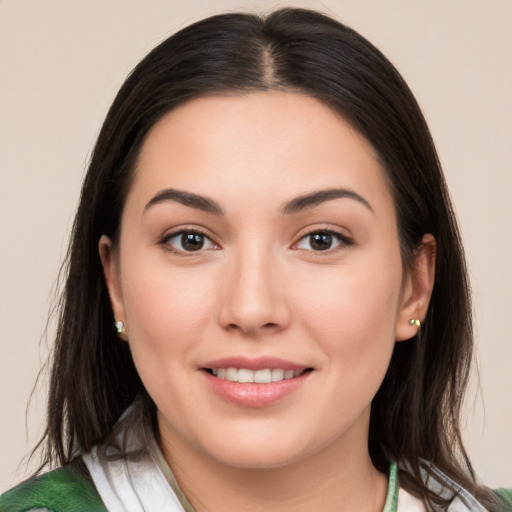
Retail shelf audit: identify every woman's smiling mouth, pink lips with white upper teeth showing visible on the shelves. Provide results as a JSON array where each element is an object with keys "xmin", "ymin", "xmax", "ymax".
[{"xmin": 201, "ymin": 357, "xmax": 313, "ymax": 407}]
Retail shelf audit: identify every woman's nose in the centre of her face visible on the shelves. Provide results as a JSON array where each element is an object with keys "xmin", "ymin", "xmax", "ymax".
[{"xmin": 219, "ymin": 249, "xmax": 291, "ymax": 337}]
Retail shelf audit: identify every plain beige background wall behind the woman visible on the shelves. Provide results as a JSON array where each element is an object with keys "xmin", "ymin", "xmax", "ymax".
[{"xmin": 0, "ymin": 0, "xmax": 512, "ymax": 491}]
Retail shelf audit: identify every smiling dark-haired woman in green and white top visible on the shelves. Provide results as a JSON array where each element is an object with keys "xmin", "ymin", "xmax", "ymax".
[{"xmin": 0, "ymin": 9, "xmax": 506, "ymax": 512}]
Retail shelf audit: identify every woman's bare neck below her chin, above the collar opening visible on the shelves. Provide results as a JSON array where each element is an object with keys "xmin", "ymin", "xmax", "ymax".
[{"xmin": 161, "ymin": 420, "xmax": 387, "ymax": 512}]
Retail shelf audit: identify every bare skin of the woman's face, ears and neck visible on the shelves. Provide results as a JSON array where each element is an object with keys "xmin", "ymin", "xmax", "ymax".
[{"xmin": 100, "ymin": 92, "xmax": 435, "ymax": 511}]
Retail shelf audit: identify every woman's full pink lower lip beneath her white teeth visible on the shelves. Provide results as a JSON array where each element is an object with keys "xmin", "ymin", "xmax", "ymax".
[{"xmin": 203, "ymin": 372, "xmax": 311, "ymax": 408}]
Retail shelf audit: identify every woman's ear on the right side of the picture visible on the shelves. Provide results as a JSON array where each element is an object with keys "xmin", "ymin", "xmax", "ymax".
[{"xmin": 396, "ymin": 233, "xmax": 436, "ymax": 341}]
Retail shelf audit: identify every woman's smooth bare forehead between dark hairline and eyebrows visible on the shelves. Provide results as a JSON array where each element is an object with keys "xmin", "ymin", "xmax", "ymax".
[{"xmin": 129, "ymin": 92, "xmax": 390, "ymax": 215}]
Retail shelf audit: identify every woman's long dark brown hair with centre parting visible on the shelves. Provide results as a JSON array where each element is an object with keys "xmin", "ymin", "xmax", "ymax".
[{"xmin": 35, "ymin": 9, "xmax": 492, "ymax": 508}]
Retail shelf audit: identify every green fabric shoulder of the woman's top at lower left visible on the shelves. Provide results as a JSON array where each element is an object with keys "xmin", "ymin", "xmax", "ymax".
[{"xmin": 0, "ymin": 460, "xmax": 107, "ymax": 512}]
